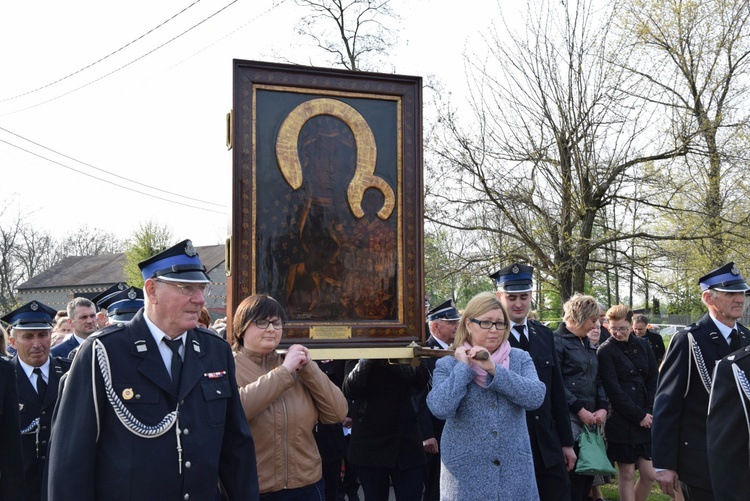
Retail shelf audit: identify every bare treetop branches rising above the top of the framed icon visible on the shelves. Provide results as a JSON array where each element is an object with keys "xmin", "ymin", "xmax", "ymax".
[{"xmin": 294, "ymin": 0, "xmax": 398, "ymax": 70}]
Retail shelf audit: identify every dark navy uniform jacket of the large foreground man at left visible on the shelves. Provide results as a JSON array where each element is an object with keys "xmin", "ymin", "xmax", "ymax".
[{"xmin": 48, "ymin": 310, "xmax": 258, "ymax": 501}]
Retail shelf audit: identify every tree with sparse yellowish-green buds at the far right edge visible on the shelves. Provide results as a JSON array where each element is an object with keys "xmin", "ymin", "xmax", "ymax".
[{"xmin": 615, "ymin": 0, "xmax": 750, "ymax": 268}]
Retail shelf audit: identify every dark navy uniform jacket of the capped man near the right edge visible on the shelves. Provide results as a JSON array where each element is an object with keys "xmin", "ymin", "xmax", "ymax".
[{"xmin": 651, "ymin": 313, "xmax": 750, "ymax": 490}]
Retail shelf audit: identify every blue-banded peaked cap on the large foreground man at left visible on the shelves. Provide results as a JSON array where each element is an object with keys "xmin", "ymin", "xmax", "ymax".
[{"xmin": 138, "ymin": 240, "xmax": 211, "ymax": 284}]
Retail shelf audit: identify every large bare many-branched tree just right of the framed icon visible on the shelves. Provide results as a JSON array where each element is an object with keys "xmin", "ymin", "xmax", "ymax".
[{"xmin": 427, "ymin": 0, "xmax": 687, "ymax": 301}]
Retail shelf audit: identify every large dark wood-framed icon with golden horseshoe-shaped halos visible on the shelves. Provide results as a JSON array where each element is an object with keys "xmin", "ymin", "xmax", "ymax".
[{"xmin": 227, "ymin": 60, "xmax": 424, "ymax": 347}]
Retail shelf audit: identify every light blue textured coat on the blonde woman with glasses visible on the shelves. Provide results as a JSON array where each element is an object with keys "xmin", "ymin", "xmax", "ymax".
[{"xmin": 427, "ymin": 348, "xmax": 545, "ymax": 501}]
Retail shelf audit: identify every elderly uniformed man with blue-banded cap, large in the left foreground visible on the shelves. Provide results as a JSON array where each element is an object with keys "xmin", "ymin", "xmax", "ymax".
[{"xmin": 48, "ymin": 240, "xmax": 258, "ymax": 501}]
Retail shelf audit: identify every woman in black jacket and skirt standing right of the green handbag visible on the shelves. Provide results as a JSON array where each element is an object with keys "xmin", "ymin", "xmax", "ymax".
[{"xmin": 597, "ymin": 305, "xmax": 658, "ymax": 501}]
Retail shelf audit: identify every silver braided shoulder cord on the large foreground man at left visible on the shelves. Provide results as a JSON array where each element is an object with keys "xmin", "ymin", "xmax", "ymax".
[{"xmin": 91, "ymin": 339, "xmax": 182, "ymax": 474}]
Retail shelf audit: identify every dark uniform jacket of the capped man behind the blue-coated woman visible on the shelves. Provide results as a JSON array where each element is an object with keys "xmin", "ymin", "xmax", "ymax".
[{"xmin": 508, "ymin": 320, "xmax": 573, "ymax": 468}]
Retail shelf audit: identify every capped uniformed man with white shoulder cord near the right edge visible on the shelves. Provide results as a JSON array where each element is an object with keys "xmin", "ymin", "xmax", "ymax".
[{"xmin": 651, "ymin": 263, "xmax": 750, "ymax": 501}]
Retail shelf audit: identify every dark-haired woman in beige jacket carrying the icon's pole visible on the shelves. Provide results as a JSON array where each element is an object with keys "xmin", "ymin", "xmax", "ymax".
[{"xmin": 232, "ymin": 294, "xmax": 347, "ymax": 501}]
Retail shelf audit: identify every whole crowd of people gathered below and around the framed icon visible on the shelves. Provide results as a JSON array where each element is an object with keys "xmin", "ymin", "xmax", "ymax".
[{"xmin": 0, "ymin": 246, "xmax": 750, "ymax": 501}]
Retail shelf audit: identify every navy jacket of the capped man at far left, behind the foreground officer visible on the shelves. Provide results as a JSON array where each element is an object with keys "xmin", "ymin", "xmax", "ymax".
[{"xmin": 11, "ymin": 355, "xmax": 70, "ymax": 500}]
